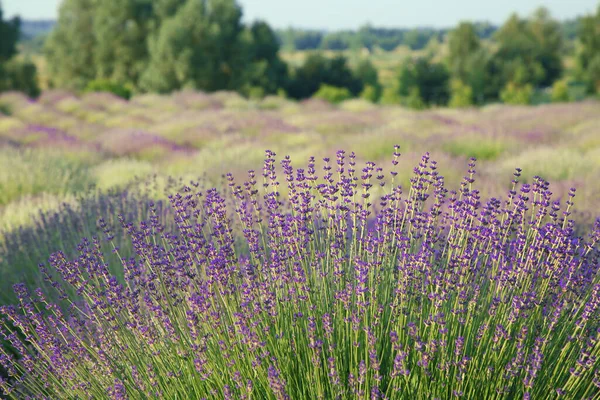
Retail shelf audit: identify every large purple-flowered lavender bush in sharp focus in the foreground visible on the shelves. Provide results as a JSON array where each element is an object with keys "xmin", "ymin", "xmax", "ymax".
[{"xmin": 0, "ymin": 148, "xmax": 600, "ymax": 399}]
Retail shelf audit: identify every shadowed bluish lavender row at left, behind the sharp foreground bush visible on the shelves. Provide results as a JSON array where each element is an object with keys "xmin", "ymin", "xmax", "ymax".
[{"xmin": 0, "ymin": 178, "xmax": 182, "ymax": 304}]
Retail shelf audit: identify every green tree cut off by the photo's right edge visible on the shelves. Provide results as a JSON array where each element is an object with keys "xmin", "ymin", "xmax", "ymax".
[{"xmin": 577, "ymin": 6, "xmax": 600, "ymax": 93}]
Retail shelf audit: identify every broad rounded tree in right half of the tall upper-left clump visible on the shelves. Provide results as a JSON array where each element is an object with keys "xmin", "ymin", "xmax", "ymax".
[{"xmin": 141, "ymin": 0, "xmax": 247, "ymax": 92}]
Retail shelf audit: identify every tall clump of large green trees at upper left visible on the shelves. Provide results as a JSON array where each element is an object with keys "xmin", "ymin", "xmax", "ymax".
[{"xmin": 46, "ymin": 0, "xmax": 287, "ymax": 93}]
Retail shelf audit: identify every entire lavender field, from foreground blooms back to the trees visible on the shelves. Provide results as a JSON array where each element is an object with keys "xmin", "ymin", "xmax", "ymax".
[{"xmin": 0, "ymin": 91, "xmax": 600, "ymax": 399}]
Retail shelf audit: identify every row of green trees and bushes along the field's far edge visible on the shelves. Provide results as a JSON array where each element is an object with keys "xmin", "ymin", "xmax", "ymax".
[{"xmin": 0, "ymin": 0, "xmax": 600, "ymax": 108}]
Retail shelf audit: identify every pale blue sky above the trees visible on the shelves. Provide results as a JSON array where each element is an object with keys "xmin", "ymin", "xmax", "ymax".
[{"xmin": 0, "ymin": 0, "xmax": 600, "ymax": 30}]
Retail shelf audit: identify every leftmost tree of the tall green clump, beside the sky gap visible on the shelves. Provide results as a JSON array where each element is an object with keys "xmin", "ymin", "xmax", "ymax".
[{"xmin": 45, "ymin": 0, "xmax": 97, "ymax": 90}]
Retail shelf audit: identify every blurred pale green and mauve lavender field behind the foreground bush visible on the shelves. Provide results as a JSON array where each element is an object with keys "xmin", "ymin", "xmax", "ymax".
[{"xmin": 0, "ymin": 91, "xmax": 600, "ymax": 228}]
